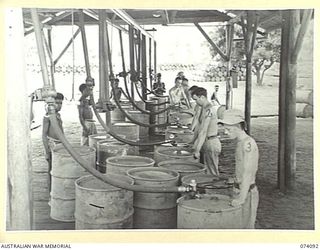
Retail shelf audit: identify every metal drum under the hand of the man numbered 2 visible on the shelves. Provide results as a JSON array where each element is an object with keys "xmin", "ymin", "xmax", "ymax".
[{"xmin": 154, "ymin": 147, "xmax": 199, "ymax": 164}]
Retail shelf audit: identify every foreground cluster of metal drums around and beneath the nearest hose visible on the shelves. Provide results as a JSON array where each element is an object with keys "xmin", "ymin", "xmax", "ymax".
[{"xmin": 50, "ymin": 140, "xmax": 250, "ymax": 229}]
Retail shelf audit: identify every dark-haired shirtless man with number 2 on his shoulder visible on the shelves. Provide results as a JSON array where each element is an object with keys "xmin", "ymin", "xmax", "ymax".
[{"xmin": 192, "ymin": 88, "xmax": 221, "ymax": 176}]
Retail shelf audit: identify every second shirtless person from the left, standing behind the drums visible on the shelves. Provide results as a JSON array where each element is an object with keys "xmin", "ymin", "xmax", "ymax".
[{"xmin": 78, "ymin": 83, "xmax": 97, "ymax": 145}]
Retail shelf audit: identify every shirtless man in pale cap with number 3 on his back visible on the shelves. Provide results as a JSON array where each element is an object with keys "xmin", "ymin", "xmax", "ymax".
[{"xmin": 218, "ymin": 109, "xmax": 259, "ymax": 228}]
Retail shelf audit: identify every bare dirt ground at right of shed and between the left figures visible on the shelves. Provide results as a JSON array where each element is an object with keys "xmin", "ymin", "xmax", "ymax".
[{"xmin": 31, "ymin": 80, "xmax": 315, "ymax": 230}]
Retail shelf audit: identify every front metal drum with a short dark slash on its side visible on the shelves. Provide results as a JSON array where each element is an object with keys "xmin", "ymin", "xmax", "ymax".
[{"xmin": 75, "ymin": 174, "xmax": 133, "ymax": 230}]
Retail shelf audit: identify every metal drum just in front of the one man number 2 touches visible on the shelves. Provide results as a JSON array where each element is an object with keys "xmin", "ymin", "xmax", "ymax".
[{"xmin": 158, "ymin": 160, "xmax": 206, "ymax": 184}]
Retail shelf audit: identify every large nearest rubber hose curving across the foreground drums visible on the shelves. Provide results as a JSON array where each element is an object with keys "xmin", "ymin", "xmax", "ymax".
[{"xmin": 49, "ymin": 114, "xmax": 185, "ymax": 193}]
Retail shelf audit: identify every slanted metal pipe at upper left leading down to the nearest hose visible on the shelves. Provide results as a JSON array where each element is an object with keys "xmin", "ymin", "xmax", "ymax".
[{"xmin": 30, "ymin": 8, "xmax": 50, "ymax": 87}]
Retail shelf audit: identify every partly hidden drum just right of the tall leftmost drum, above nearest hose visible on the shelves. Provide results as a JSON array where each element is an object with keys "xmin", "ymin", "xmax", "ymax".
[{"xmin": 97, "ymin": 140, "xmax": 139, "ymax": 173}]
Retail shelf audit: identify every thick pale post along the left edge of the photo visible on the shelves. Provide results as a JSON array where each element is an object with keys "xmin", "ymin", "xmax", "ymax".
[{"xmin": 4, "ymin": 8, "xmax": 32, "ymax": 230}]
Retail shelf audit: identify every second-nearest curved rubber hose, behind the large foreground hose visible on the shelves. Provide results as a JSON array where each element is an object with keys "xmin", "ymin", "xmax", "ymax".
[{"xmin": 90, "ymin": 94, "xmax": 173, "ymax": 146}]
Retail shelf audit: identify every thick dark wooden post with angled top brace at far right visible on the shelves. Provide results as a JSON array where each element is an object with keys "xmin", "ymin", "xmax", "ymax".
[{"xmin": 278, "ymin": 10, "xmax": 312, "ymax": 192}]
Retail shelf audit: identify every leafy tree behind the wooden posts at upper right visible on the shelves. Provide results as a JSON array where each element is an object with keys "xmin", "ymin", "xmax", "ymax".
[{"xmin": 206, "ymin": 25, "xmax": 281, "ymax": 86}]
